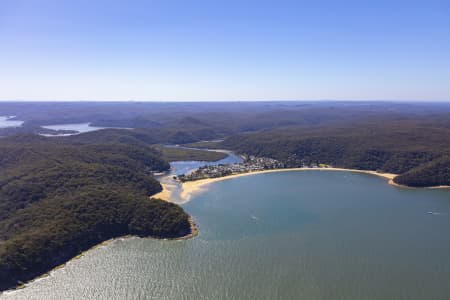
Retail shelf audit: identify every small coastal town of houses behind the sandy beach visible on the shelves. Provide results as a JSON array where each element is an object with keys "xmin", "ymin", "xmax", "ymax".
[{"xmin": 177, "ymin": 155, "xmax": 328, "ymax": 182}]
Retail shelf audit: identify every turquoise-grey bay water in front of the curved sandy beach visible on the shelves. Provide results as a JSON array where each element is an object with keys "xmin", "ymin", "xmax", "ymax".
[{"xmin": 0, "ymin": 171, "xmax": 450, "ymax": 300}]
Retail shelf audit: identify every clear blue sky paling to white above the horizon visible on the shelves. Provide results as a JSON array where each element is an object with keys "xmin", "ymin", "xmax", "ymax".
[{"xmin": 0, "ymin": 0, "xmax": 450, "ymax": 101}]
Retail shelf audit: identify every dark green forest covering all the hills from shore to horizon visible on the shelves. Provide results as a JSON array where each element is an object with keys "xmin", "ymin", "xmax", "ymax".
[{"xmin": 0, "ymin": 102, "xmax": 450, "ymax": 289}]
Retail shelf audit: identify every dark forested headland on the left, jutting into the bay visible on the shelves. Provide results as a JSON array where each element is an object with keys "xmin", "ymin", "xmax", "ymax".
[{"xmin": 0, "ymin": 136, "xmax": 190, "ymax": 289}]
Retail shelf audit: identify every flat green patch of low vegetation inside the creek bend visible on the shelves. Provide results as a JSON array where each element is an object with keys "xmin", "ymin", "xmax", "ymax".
[{"xmin": 159, "ymin": 147, "xmax": 228, "ymax": 161}]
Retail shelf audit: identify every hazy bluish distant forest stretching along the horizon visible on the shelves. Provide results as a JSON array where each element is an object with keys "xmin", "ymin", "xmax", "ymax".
[{"xmin": 0, "ymin": 101, "xmax": 450, "ymax": 139}]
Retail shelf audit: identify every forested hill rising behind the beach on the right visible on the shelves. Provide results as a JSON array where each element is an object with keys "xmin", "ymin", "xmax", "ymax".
[{"xmin": 220, "ymin": 116, "xmax": 450, "ymax": 187}]
